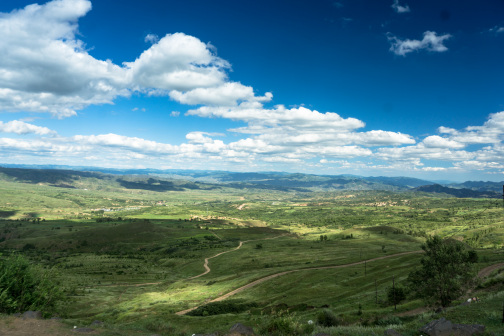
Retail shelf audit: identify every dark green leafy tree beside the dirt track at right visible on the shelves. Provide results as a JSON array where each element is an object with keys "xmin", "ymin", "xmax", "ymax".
[{"xmin": 408, "ymin": 236, "xmax": 478, "ymax": 307}]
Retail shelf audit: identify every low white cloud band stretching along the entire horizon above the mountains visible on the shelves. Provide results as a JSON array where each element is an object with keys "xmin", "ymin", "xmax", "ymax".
[{"xmin": 0, "ymin": 111, "xmax": 504, "ymax": 177}]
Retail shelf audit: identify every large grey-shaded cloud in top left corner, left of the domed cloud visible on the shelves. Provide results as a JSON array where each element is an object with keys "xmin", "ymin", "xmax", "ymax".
[{"xmin": 0, "ymin": 0, "xmax": 132, "ymax": 117}]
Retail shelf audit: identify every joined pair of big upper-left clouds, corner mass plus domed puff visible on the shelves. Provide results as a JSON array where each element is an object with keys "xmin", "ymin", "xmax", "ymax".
[{"xmin": 0, "ymin": 0, "xmax": 252, "ymax": 118}]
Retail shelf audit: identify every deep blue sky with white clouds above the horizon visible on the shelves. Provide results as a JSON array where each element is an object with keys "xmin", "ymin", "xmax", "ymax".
[{"xmin": 0, "ymin": 0, "xmax": 504, "ymax": 181}]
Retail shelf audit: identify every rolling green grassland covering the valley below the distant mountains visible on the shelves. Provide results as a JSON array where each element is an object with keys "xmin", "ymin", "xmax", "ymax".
[{"xmin": 0, "ymin": 175, "xmax": 504, "ymax": 335}]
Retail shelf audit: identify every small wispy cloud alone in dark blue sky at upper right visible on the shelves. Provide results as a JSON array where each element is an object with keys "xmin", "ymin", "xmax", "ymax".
[{"xmin": 387, "ymin": 31, "xmax": 452, "ymax": 56}]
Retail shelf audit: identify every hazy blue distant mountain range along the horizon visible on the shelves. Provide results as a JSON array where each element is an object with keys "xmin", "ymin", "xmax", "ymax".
[{"xmin": 0, "ymin": 164, "xmax": 504, "ymax": 198}]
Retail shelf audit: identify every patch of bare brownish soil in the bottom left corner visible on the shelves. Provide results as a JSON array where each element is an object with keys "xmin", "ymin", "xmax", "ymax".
[{"xmin": 0, "ymin": 316, "xmax": 97, "ymax": 336}]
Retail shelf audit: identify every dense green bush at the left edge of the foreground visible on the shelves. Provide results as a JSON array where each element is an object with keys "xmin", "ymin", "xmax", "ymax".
[{"xmin": 0, "ymin": 254, "xmax": 64, "ymax": 315}]
